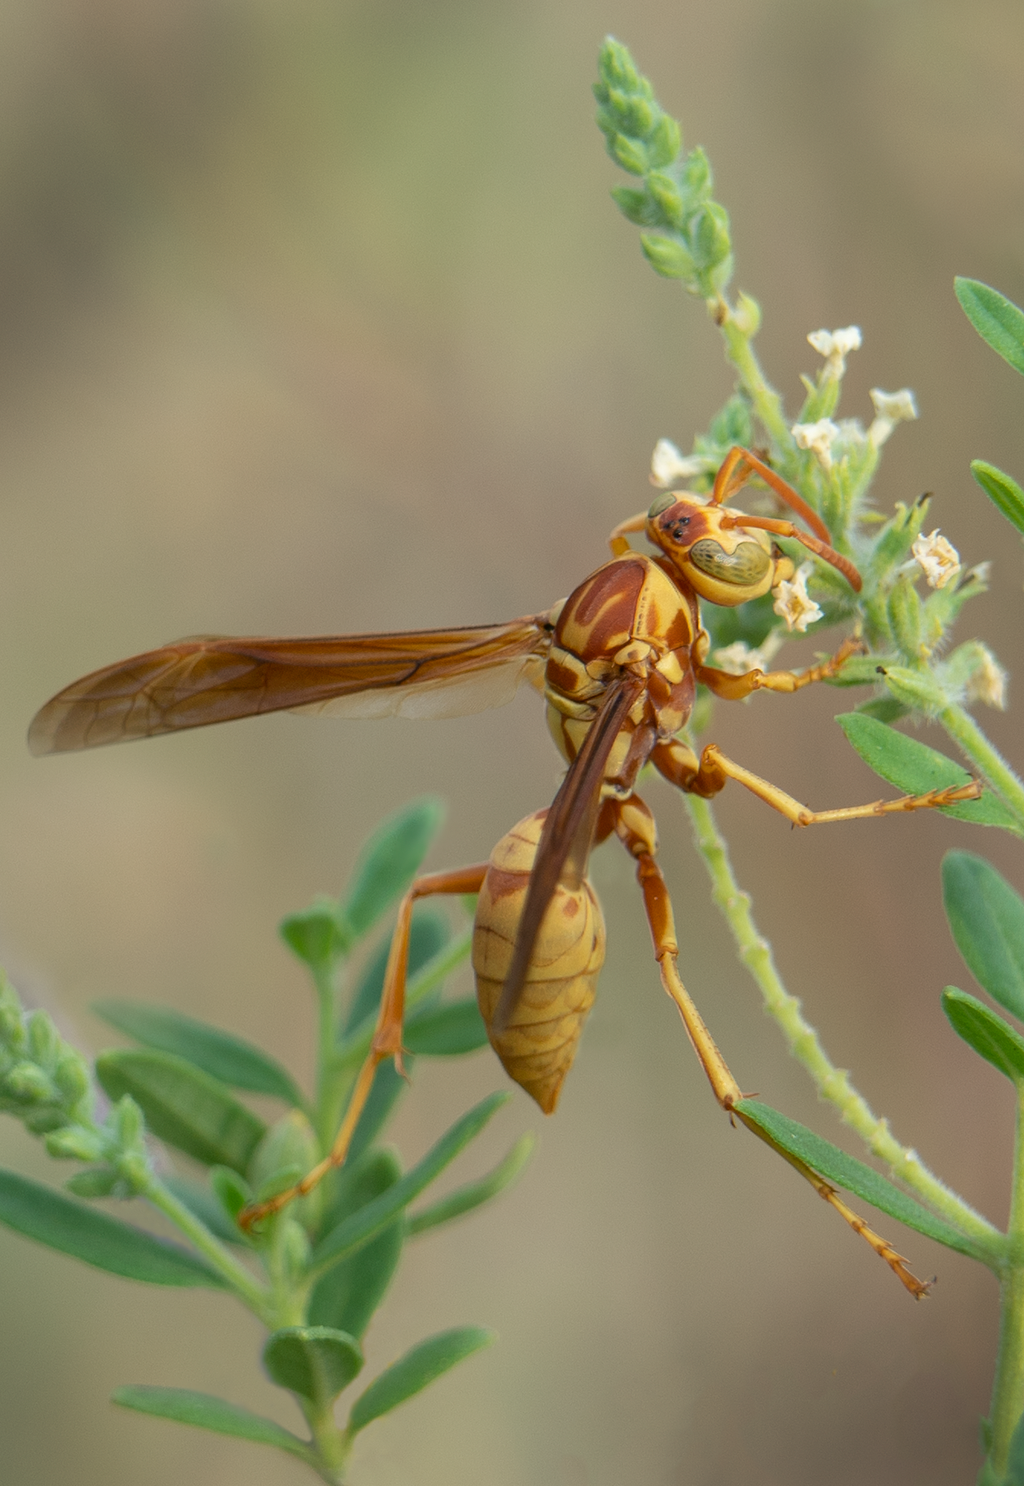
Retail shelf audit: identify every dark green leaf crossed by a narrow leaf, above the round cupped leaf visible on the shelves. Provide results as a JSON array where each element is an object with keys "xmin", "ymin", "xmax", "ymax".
[{"xmin": 308, "ymin": 1150, "xmax": 406, "ymax": 1337}]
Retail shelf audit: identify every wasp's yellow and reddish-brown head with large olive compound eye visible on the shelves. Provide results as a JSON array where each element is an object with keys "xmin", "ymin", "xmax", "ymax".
[{"xmin": 647, "ymin": 490, "xmax": 794, "ymax": 608}]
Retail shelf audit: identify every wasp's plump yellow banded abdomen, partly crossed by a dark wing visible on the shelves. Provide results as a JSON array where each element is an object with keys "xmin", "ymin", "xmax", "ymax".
[{"xmin": 473, "ymin": 810, "xmax": 605, "ymax": 1115}]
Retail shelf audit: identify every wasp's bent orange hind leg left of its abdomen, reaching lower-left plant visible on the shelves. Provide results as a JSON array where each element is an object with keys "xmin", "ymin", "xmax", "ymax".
[{"xmin": 238, "ymin": 862, "xmax": 487, "ymax": 1230}]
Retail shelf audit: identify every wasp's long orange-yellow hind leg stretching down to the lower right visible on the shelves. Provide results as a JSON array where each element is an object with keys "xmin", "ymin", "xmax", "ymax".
[{"xmin": 612, "ymin": 796, "xmax": 929, "ymax": 1300}]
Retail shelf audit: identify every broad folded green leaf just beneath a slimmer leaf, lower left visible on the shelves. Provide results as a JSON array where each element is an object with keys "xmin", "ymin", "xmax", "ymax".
[{"xmin": 97, "ymin": 1049, "xmax": 266, "ymax": 1172}]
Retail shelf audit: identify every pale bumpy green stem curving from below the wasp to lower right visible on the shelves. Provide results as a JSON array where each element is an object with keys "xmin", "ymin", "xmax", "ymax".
[{"xmin": 684, "ymin": 795, "xmax": 1006, "ymax": 1268}]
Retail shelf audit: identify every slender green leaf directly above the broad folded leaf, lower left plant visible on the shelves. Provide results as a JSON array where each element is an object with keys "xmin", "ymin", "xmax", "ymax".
[{"xmin": 92, "ymin": 1002, "xmax": 303, "ymax": 1107}]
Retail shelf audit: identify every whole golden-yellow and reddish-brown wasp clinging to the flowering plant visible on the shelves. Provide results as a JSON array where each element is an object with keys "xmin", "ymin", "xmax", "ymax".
[{"xmin": 30, "ymin": 447, "xmax": 979, "ymax": 1293}]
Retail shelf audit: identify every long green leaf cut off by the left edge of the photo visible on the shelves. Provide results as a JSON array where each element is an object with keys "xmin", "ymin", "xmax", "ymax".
[{"xmin": 0, "ymin": 1171, "xmax": 224, "ymax": 1290}]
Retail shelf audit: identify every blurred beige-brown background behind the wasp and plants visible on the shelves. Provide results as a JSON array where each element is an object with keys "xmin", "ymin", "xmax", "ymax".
[{"xmin": 0, "ymin": 0, "xmax": 1024, "ymax": 1486}]
